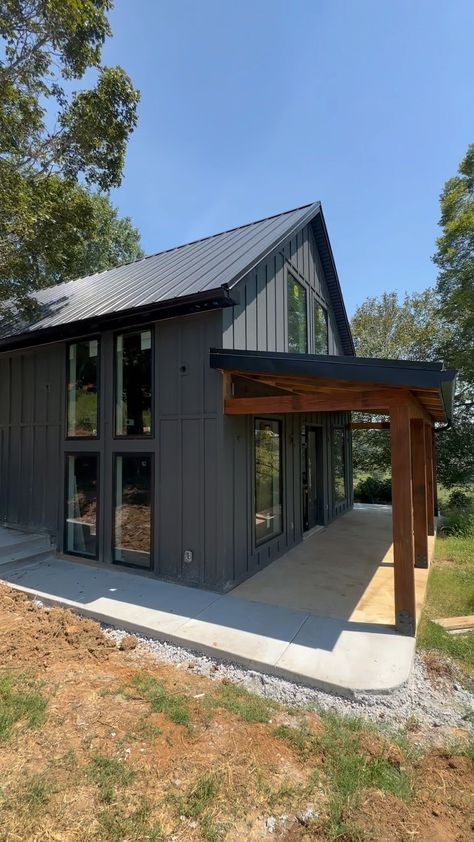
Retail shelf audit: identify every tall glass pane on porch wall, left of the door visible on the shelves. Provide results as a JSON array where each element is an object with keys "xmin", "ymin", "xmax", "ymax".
[{"xmin": 255, "ymin": 421, "xmax": 283, "ymax": 544}]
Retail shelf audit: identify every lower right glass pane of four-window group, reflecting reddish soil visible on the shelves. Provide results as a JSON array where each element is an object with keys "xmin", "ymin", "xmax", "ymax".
[{"xmin": 114, "ymin": 455, "xmax": 151, "ymax": 567}]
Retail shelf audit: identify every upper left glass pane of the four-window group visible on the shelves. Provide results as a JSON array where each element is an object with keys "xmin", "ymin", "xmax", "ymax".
[{"xmin": 67, "ymin": 339, "xmax": 99, "ymax": 438}]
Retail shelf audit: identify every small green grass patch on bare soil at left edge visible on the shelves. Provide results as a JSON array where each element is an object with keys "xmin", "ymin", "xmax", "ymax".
[{"xmin": 0, "ymin": 672, "xmax": 48, "ymax": 742}]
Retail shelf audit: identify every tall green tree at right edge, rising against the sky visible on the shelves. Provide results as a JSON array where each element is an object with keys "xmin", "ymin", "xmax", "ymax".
[{"xmin": 433, "ymin": 144, "xmax": 474, "ymax": 383}]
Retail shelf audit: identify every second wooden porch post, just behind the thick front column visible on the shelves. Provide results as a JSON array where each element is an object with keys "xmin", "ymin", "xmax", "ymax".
[{"xmin": 410, "ymin": 418, "xmax": 428, "ymax": 567}]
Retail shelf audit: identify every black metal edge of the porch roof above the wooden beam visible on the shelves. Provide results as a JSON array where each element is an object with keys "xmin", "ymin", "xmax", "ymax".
[{"xmin": 210, "ymin": 348, "xmax": 456, "ymax": 420}]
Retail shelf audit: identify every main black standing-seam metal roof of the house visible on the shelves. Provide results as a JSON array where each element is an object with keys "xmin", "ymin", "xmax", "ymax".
[{"xmin": 0, "ymin": 202, "xmax": 354, "ymax": 354}]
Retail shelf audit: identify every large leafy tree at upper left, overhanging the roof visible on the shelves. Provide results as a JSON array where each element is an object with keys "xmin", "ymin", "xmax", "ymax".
[{"xmin": 0, "ymin": 0, "xmax": 140, "ymax": 301}]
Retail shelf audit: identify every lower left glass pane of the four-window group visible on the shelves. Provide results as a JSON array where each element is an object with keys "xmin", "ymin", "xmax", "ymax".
[{"xmin": 65, "ymin": 454, "xmax": 98, "ymax": 557}]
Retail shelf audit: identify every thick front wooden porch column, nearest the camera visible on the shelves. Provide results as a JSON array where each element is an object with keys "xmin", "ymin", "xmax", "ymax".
[{"xmin": 390, "ymin": 403, "xmax": 416, "ymax": 635}]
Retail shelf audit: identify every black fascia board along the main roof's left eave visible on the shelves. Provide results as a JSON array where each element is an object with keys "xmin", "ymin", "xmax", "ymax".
[{"xmin": 0, "ymin": 287, "xmax": 238, "ymax": 353}]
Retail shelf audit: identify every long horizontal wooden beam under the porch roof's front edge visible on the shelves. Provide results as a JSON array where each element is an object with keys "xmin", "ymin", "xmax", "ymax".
[{"xmin": 224, "ymin": 389, "xmax": 409, "ymax": 415}]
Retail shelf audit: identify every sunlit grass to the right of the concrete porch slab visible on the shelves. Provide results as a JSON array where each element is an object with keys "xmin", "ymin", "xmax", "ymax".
[{"xmin": 418, "ymin": 534, "xmax": 474, "ymax": 680}]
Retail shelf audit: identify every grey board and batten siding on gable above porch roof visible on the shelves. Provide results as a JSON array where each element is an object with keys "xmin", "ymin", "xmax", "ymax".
[{"xmin": 222, "ymin": 224, "xmax": 343, "ymax": 355}]
